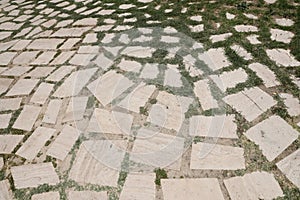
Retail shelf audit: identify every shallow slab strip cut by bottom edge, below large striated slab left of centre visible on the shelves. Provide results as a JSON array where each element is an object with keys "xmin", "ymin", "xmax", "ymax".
[{"xmin": 68, "ymin": 191, "xmax": 108, "ymax": 200}]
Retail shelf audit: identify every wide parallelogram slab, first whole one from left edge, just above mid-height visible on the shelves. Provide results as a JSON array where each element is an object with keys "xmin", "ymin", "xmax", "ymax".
[{"xmin": 5, "ymin": 79, "xmax": 39, "ymax": 96}]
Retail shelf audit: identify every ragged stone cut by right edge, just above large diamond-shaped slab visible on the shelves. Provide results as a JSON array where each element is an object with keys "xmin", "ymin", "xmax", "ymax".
[{"xmin": 279, "ymin": 93, "xmax": 300, "ymax": 116}]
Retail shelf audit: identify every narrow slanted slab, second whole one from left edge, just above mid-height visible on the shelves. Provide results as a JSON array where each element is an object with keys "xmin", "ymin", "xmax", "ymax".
[{"xmin": 30, "ymin": 83, "xmax": 54, "ymax": 104}]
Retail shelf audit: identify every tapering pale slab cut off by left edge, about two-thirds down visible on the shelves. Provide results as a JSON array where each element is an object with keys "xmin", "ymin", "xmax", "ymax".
[{"xmin": 0, "ymin": 135, "xmax": 24, "ymax": 154}]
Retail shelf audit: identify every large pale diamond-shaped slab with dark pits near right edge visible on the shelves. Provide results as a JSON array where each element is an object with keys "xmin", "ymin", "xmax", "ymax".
[{"xmin": 245, "ymin": 116, "xmax": 299, "ymax": 161}]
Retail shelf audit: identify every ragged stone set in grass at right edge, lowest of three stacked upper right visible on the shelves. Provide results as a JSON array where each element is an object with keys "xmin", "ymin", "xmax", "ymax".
[{"xmin": 266, "ymin": 49, "xmax": 300, "ymax": 67}]
